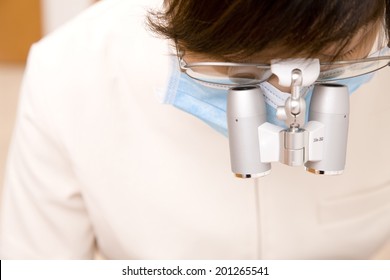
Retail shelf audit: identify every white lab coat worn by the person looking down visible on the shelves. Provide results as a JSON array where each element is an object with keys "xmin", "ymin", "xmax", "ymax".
[{"xmin": 0, "ymin": 0, "xmax": 390, "ymax": 259}]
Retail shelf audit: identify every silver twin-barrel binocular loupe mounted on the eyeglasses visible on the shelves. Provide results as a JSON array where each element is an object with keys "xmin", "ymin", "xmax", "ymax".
[{"xmin": 227, "ymin": 59, "xmax": 349, "ymax": 178}]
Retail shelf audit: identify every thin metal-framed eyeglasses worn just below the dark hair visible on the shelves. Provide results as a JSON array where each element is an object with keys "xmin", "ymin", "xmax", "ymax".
[{"xmin": 178, "ymin": 38, "xmax": 390, "ymax": 86}]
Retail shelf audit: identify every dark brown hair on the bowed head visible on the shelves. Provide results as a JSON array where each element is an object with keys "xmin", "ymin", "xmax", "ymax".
[{"xmin": 147, "ymin": 0, "xmax": 390, "ymax": 58}]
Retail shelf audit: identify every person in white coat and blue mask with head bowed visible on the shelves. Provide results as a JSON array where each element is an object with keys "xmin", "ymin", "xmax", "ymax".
[{"xmin": 0, "ymin": 0, "xmax": 390, "ymax": 259}]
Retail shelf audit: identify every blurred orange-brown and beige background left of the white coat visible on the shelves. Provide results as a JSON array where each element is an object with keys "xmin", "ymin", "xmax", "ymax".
[{"xmin": 0, "ymin": 0, "xmax": 97, "ymax": 186}]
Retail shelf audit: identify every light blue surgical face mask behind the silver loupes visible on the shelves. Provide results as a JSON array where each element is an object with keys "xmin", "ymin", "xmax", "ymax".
[{"xmin": 162, "ymin": 59, "xmax": 373, "ymax": 136}]
